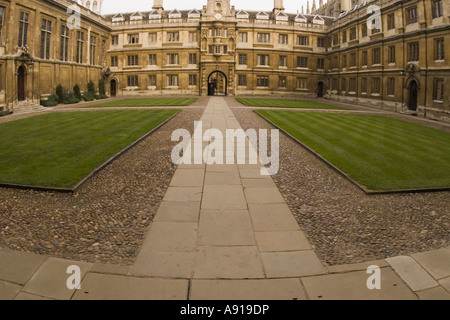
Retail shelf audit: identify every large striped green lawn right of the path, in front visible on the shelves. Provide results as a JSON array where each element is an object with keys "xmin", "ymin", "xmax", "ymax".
[{"xmin": 258, "ymin": 110, "xmax": 450, "ymax": 190}]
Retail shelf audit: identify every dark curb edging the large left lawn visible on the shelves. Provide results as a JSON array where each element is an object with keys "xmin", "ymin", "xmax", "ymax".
[{"xmin": 0, "ymin": 110, "xmax": 181, "ymax": 193}]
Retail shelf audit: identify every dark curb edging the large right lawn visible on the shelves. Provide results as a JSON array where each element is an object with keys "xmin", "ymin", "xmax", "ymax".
[{"xmin": 253, "ymin": 110, "xmax": 450, "ymax": 195}]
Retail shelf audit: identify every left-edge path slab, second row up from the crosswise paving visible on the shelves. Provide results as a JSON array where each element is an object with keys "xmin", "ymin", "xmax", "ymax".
[{"xmin": 141, "ymin": 222, "xmax": 198, "ymax": 252}]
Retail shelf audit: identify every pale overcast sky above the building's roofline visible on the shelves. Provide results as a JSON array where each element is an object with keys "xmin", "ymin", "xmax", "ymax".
[{"xmin": 102, "ymin": 0, "xmax": 320, "ymax": 14}]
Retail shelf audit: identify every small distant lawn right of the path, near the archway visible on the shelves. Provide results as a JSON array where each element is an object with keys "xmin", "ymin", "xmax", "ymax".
[{"xmin": 236, "ymin": 98, "xmax": 346, "ymax": 110}]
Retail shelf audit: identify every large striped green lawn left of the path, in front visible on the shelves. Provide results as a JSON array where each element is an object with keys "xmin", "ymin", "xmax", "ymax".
[{"xmin": 0, "ymin": 110, "xmax": 178, "ymax": 188}]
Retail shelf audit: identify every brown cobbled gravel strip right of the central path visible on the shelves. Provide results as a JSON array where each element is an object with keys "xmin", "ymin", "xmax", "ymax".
[{"xmin": 232, "ymin": 108, "xmax": 450, "ymax": 265}]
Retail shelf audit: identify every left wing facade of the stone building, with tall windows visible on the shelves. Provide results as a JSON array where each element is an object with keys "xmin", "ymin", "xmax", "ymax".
[{"xmin": 0, "ymin": 0, "xmax": 110, "ymax": 110}]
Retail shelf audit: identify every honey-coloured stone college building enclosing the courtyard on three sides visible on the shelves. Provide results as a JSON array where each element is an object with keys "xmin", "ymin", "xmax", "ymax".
[{"xmin": 0, "ymin": 0, "xmax": 450, "ymax": 119}]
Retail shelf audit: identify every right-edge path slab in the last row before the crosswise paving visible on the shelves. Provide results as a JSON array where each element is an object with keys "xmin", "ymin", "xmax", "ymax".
[{"xmin": 261, "ymin": 250, "xmax": 326, "ymax": 278}]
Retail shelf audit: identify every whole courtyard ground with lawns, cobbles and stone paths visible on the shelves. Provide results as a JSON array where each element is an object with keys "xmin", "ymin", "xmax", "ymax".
[{"xmin": 0, "ymin": 97, "xmax": 450, "ymax": 300}]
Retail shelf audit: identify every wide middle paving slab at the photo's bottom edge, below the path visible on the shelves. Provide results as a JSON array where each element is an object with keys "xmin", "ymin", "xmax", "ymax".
[{"xmin": 189, "ymin": 278, "xmax": 306, "ymax": 301}]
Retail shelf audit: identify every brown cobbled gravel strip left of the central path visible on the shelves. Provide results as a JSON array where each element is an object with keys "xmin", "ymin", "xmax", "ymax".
[{"xmin": 0, "ymin": 107, "xmax": 204, "ymax": 265}]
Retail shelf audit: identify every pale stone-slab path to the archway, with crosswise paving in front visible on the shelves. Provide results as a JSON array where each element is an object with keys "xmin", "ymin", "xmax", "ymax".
[{"xmin": 0, "ymin": 98, "xmax": 450, "ymax": 300}]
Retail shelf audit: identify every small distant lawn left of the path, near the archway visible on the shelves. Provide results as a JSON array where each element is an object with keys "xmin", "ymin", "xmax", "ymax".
[{"xmin": 85, "ymin": 98, "xmax": 198, "ymax": 108}]
